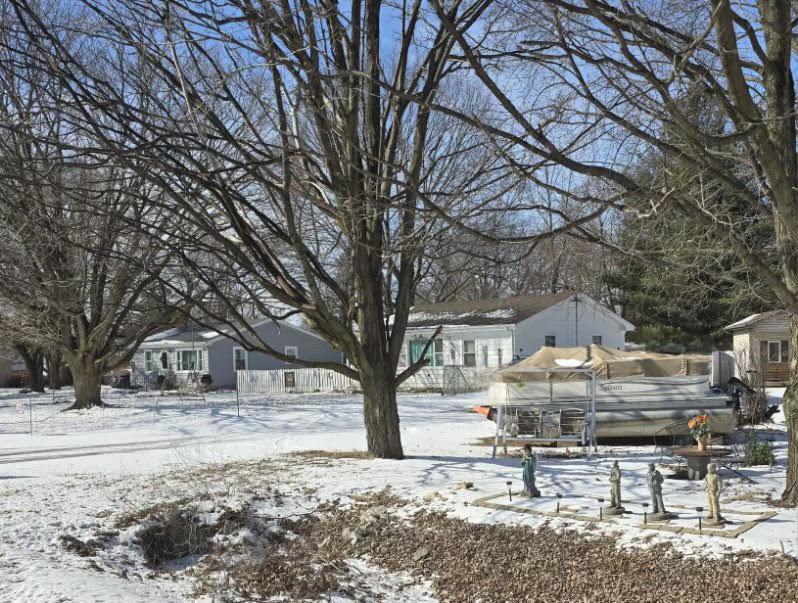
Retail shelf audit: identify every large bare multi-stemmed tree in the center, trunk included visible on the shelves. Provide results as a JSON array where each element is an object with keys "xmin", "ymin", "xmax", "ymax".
[{"xmin": 10, "ymin": 0, "xmax": 505, "ymax": 458}]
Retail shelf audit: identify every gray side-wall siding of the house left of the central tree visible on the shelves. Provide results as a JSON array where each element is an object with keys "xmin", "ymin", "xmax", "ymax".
[{"xmin": 208, "ymin": 322, "xmax": 342, "ymax": 387}]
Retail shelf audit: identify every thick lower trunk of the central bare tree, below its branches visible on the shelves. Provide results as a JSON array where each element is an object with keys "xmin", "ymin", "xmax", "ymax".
[{"xmin": 360, "ymin": 362, "xmax": 404, "ymax": 459}]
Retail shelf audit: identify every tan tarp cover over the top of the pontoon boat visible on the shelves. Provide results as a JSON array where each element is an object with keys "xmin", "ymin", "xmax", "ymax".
[{"xmin": 497, "ymin": 345, "xmax": 712, "ymax": 383}]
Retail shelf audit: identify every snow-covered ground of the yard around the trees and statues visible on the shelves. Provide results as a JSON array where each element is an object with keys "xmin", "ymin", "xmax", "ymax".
[{"xmin": 0, "ymin": 390, "xmax": 798, "ymax": 602}]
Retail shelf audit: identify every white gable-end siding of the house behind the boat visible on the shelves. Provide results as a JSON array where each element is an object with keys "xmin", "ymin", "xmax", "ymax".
[{"xmin": 515, "ymin": 295, "xmax": 626, "ymax": 357}]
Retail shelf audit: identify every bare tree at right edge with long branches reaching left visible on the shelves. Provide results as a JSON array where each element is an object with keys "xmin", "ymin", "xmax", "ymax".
[{"xmin": 432, "ymin": 0, "xmax": 798, "ymax": 504}]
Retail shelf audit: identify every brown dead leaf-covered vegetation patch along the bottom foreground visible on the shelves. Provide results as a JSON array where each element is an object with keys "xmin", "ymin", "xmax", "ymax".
[{"xmin": 197, "ymin": 503, "xmax": 798, "ymax": 603}]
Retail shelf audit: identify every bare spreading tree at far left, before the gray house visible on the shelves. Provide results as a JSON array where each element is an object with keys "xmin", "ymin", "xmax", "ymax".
[{"xmin": 0, "ymin": 16, "xmax": 178, "ymax": 408}]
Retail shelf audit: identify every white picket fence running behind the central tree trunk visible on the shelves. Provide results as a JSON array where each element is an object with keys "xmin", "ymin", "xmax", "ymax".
[{"xmin": 238, "ymin": 366, "xmax": 492, "ymax": 394}]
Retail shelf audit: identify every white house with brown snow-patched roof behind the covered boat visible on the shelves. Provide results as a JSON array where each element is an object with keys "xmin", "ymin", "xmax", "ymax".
[{"xmin": 400, "ymin": 291, "xmax": 634, "ymax": 367}]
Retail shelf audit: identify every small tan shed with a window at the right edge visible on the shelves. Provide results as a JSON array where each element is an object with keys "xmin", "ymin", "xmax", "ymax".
[{"xmin": 724, "ymin": 310, "xmax": 791, "ymax": 385}]
